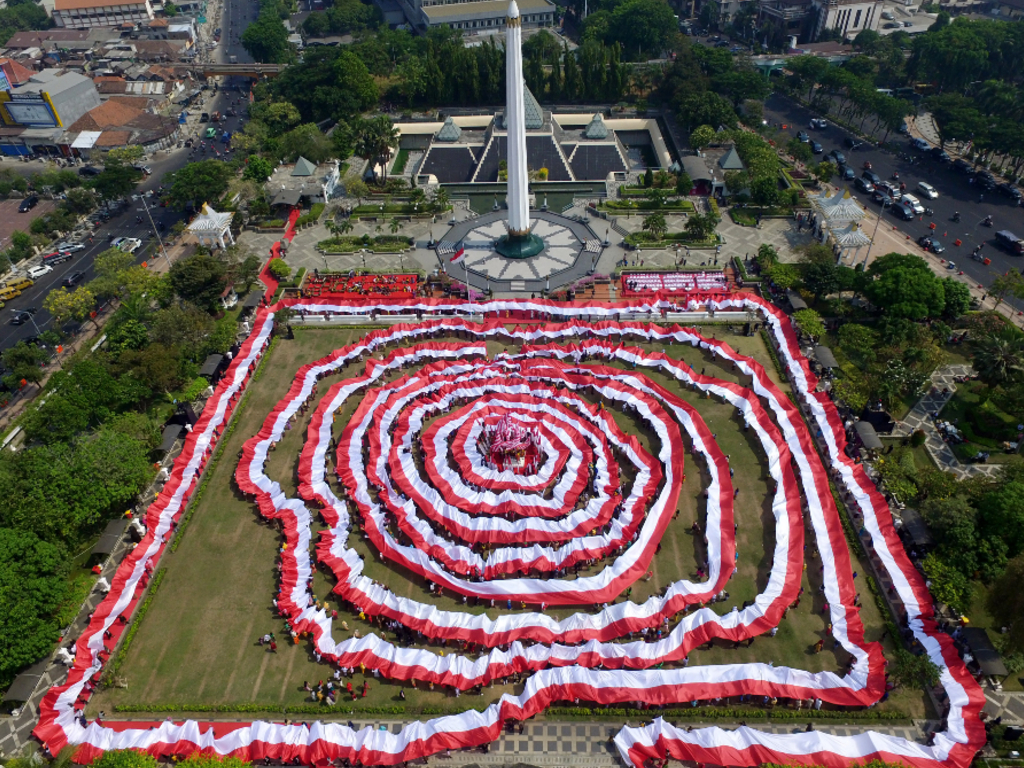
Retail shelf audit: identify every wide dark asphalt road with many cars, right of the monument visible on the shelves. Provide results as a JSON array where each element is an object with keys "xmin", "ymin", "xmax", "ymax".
[{"xmin": 765, "ymin": 95, "xmax": 1024, "ymax": 309}]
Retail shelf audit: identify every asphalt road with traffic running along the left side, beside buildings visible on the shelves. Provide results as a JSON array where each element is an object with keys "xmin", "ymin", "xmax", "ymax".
[{"xmin": 0, "ymin": 0, "xmax": 258, "ymax": 358}]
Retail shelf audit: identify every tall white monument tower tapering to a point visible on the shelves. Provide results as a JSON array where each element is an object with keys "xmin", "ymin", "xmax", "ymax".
[{"xmin": 505, "ymin": 0, "xmax": 529, "ymax": 238}]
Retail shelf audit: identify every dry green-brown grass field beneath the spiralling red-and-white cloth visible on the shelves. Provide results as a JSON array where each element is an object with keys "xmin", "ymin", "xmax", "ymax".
[{"xmin": 90, "ymin": 328, "xmax": 926, "ymax": 718}]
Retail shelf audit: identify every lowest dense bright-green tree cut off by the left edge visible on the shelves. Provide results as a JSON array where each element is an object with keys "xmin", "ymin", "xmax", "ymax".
[{"xmin": 0, "ymin": 528, "xmax": 71, "ymax": 684}]
